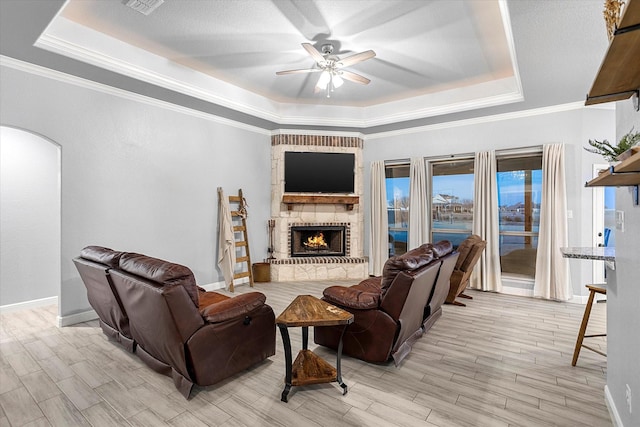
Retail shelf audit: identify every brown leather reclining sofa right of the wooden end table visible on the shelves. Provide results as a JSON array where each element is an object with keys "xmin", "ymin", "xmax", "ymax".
[{"xmin": 314, "ymin": 241, "xmax": 458, "ymax": 365}]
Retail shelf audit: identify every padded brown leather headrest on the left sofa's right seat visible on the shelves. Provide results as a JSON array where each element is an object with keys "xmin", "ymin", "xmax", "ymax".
[{"xmin": 120, "ymin": 252, "xmax": 198, "ymax": 307}]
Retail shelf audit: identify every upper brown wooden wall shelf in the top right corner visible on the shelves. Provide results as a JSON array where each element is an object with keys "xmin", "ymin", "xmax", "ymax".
[{"xmin": 585, "ymin": 0, "xmax": 640, "ymax": 108}]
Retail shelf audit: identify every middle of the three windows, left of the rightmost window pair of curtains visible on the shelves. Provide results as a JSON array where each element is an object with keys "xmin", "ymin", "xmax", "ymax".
[{"xmin": 431, "ymin": 159, "xmax": 473, "ymax": 247}]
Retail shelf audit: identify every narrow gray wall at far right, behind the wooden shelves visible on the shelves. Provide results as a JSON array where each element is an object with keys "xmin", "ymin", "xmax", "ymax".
[{"xmin": 607, "ymin": 101, "xmax": 640, "ymax": 426}]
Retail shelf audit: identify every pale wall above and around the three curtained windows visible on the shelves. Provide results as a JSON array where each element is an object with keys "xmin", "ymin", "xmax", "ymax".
[{"xmin": 363, "ymin": 106, "xmax": 615, "ymax": 296}]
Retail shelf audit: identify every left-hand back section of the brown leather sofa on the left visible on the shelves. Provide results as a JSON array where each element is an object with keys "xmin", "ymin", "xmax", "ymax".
[{"xmin": 73, "ymin": 246, "xmax": 135, "ymax": 352}]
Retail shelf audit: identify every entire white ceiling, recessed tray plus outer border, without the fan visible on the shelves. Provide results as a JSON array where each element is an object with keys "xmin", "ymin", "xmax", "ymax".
[{"xmin": 0, "ymin": 0, "xmax": 608, "ymax": 132}]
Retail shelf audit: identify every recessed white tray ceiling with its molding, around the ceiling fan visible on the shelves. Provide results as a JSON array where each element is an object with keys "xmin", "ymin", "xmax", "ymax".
[{"xmin": 37, "ymin": 0, "xmax": 522, "ymax": 127}]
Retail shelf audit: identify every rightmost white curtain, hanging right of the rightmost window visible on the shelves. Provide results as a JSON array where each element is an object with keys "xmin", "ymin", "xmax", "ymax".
[{"xmin": 533, "ymin": 144, "xmax": 572, "ymax": 301}]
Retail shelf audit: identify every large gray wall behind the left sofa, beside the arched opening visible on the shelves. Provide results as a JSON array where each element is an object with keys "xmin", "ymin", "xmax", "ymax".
[{"xmin": 0, "ymin": 62, "xmax": 271, "ymax": 316}]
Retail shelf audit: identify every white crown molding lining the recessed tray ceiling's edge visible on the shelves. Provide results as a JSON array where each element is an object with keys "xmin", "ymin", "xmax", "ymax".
[{"xmin": 35, "ymin": 11, "xmax": 523, "ymax": 128}]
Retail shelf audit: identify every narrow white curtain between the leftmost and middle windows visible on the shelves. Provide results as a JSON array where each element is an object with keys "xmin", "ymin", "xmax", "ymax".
[{"xmin": 408, "ymin": 157, "xmax": 430, "ymax": 249}]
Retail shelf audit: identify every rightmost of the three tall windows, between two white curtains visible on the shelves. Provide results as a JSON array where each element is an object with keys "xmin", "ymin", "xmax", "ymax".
[{"xmin": 497, "ymin": 154, "xmax": 542, "ymax": 278}]
